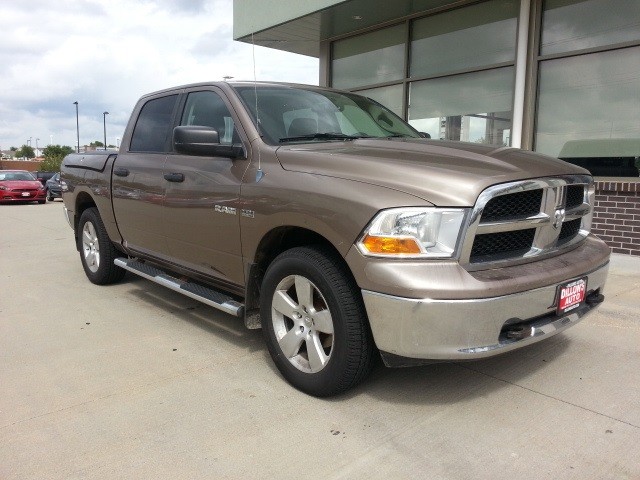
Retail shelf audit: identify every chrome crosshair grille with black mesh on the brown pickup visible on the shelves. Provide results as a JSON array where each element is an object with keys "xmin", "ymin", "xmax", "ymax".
[{"xmin": 461, "ymin": 175, "xmax": 593, "ymax": 270}]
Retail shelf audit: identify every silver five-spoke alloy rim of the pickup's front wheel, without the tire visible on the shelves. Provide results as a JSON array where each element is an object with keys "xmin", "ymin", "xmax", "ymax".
[{"xmin": 271, "ymin": 275, "xmax": 333, "ymax": 373}]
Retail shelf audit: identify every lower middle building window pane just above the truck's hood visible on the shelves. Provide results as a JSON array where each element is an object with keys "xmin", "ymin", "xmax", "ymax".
[{"xmin": 409, "ymin": 67, "xmax": 514, "ymax": 145}]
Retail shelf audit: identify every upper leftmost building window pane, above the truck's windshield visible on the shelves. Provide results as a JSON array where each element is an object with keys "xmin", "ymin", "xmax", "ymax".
[{"xmin": 331, "ymin": 25, "xmax": 405, "ymax": 88}]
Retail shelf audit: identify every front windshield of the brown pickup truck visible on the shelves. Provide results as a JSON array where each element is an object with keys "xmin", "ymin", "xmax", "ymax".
[{"xmin": 235, "ymin": 85, "xmax": 420, "ymax": 145}]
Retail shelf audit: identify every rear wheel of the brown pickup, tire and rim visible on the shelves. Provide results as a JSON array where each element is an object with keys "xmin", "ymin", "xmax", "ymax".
[{"xmin": 78, "ymin": 208, "xmax": 126, "ymax": 285}]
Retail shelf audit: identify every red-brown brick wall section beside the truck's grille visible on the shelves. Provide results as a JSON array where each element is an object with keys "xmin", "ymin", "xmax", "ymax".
[{"xmin": 591, "ymin": 182, "xmax": 640, "ymax": 256}]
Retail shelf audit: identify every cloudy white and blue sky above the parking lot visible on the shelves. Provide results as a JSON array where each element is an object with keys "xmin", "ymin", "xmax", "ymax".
[{"xmin": 0, "ymin": 0, "xmax": 318, "ymax": 150}]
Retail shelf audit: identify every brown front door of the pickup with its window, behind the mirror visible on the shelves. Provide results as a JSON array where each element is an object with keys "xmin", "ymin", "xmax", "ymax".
[{"xmin": 163, "ymin": 87, "xmax": 248, "ymax": 287}]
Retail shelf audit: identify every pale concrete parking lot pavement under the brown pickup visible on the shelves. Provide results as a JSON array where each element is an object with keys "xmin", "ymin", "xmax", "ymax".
[{"xmin": 0, "ymin": 200, "xmax": 640, "ymax": 480}]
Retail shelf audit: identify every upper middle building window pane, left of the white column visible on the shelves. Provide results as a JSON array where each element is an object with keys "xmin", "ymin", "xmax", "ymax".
[{"xmin": 411, "ymin": 0, "xmax": 519, "ymax": 77}]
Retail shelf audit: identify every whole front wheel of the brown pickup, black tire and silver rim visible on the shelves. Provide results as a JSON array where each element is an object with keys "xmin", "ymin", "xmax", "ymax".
[{"xmin": 260, "ymin": 247, "xmax": 374, "ymax": 397}]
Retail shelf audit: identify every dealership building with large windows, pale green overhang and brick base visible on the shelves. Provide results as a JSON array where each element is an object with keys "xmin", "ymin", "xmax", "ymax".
[{"xmin": 234, "ymin": 0, "xmax": 640, "ymax": 255}]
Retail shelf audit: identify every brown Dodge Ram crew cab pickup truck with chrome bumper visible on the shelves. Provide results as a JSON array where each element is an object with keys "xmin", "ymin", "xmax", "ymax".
[{"xmin": 61, "ymin": 82, "xmax": 609, "ymax": 396}]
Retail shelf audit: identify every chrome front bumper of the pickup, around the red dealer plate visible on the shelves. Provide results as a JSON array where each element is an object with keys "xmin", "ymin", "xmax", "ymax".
[{"xmin": 362, "ymin": 262, "xmax": 609, "ymax": 360}]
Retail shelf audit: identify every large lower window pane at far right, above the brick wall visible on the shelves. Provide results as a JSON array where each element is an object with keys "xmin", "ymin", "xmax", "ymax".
[{"xmin": 535, "ymin": 47, "xmax": 640, "ymax": 177}]
